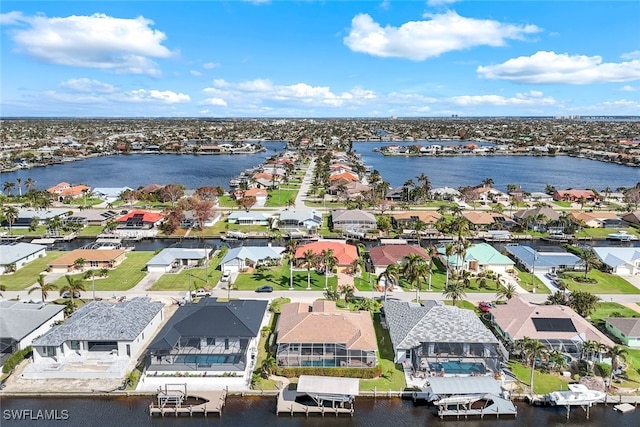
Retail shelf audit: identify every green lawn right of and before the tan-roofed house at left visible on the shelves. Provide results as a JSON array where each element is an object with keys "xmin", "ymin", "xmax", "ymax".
[{"xmin": 55, "ymin": 251, "xmax": 155, "ymax": 292}]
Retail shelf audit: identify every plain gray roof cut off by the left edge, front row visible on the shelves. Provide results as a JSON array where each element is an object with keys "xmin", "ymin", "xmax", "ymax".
[{"xmin": 0, "ymin": 301, "xmax": 64, "ymax": 341}]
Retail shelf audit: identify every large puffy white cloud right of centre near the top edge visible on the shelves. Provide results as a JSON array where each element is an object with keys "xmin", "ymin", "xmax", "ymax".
[{"xmin": 343, "ymin": 11, "xmax": 541, "ymax": 61}]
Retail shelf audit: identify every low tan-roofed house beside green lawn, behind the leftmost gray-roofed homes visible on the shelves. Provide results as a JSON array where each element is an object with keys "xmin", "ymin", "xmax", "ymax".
[{"xmin": 48, "ymin": 249, "xmax": 126, "ymax": 273}]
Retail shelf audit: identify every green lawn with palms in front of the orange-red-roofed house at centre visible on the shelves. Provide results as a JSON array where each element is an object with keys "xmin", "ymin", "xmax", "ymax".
[{"xmin": 233, "ymin": 264, "xmax": 338, "ymax": 291}]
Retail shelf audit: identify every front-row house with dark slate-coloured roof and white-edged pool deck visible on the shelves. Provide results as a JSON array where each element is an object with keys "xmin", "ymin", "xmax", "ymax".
[{"xmin": 144, "ymin": 298, "xmax": 268, "ymax": 390}]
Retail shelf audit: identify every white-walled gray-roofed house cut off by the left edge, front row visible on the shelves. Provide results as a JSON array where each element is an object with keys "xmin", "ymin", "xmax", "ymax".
[{"xmin": 0, "ymin": 301, "xmax": 65, "ymax": 366}]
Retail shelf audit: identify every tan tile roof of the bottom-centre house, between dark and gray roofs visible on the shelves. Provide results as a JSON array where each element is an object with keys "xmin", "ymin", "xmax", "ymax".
[{"xmin": 276, "ymin": 301, "xmax": 378, "ymax": 350}]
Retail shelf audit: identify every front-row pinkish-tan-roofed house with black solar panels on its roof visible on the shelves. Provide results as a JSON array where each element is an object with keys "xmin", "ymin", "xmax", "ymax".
[{"xmin": 490, "ymin": 297, "xmax": 614, "ymax": 358}]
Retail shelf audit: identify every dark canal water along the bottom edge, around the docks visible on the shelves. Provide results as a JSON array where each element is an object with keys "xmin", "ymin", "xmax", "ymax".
[{"xmin": 0, "ymin": 396, "xmax": 640, "ymax": 427}]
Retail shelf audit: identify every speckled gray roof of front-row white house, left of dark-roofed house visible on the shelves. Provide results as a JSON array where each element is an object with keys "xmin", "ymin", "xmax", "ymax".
[{"xmin": 33, "ymin": 297, "xmax": 164, "ymax": 346}]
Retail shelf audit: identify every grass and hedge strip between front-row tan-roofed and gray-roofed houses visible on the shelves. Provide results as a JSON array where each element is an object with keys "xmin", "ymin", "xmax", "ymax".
[{"xmin": 360, "ymin": 313, "xmax": 407, "ymax": 391}]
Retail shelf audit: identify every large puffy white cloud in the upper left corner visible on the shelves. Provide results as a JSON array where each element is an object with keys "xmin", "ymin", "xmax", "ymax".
[{"xmin": 2, "ymin": 12, "xmax": 175, "ymax": 76}]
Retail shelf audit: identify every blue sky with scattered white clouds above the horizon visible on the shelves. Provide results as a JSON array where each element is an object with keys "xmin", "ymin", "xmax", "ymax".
[{"xmin": 0, "ymin": 0, "xmax": 640, "ymax": 117}]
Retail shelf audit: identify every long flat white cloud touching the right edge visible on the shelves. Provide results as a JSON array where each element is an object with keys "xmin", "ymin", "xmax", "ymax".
[{"xmin": 476, "ymin": 51, "xmax": 640, "ymax": 84}]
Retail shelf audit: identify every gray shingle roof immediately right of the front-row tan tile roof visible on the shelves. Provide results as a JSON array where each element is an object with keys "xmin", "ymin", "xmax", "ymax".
[{"xmin": 384, "ymin": 301, "xmax": 498, "ymax": 349}]
